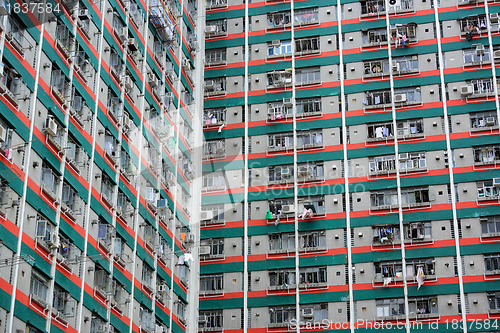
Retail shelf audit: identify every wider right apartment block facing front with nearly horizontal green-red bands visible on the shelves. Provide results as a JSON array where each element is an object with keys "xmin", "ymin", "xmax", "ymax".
[{"xmin": 198, "ymin": 0, "xmax": 500, "ymax": 332}]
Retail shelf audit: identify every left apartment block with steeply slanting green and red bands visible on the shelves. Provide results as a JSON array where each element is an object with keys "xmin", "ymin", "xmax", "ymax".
[{"xmin": 0, "ymin": 0, "xmax": 204, "ymax": 333}]
